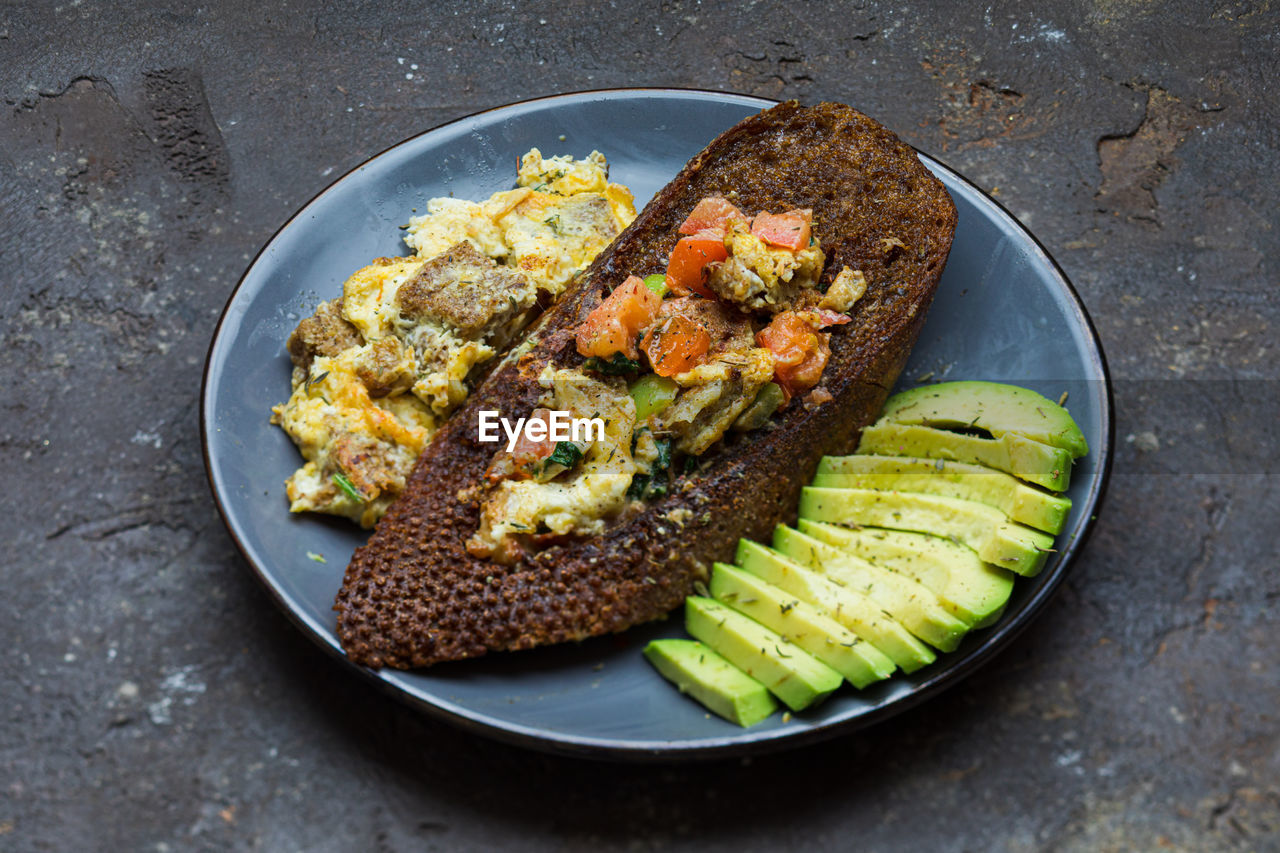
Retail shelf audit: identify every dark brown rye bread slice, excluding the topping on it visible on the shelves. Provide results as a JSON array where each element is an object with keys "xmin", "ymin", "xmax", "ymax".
[{"xmin": 334, "ymin": 102, "xmax": 956, "ymax": 667}]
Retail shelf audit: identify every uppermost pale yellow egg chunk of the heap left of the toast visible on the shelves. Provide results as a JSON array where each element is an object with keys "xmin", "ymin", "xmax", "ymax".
[{"xmin": 404, "ymin": 149, "xmax": 636, "ymax": 296}]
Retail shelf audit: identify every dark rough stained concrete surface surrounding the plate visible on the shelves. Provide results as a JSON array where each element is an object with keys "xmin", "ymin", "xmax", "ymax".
[{"xmin": 0, "ymin": 0, "xmax": 1280, "ymax": 850}]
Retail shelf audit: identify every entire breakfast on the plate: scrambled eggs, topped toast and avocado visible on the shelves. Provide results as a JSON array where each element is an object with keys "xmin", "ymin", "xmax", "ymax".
[{"xmin": 273, "ymin": 102, "xmax": 1088, "ymax": 726}]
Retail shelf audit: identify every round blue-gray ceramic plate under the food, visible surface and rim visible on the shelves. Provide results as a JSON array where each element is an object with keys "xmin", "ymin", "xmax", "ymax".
[{"xmin": 201, "ymin": 90, "xmax": 1111, "ymax": 758}]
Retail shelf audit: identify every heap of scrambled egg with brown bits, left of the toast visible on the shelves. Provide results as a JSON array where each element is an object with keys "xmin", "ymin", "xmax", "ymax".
[{"xmin": 273, "ymin": 149, "xmax": 635, "ymax": 528}]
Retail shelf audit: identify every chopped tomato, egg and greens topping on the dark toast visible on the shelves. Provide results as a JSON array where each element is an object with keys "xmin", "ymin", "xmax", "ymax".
[{"xmin": 467, "ymin": 196, "xmax": 865, "ymax": 562}]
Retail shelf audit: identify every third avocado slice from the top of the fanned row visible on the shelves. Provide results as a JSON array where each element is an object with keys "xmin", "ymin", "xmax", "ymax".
[{"xmin": 813, "ymin": 456, "xmax": 1071, "ymax": 533}]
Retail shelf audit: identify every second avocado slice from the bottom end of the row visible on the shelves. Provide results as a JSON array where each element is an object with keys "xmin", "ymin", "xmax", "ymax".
[{"xmin": 685, "ymin": 596, "xmax": 845, "ymax": 711}]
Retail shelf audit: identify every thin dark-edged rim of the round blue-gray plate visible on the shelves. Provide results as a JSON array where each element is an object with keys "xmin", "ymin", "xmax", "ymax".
[{"xmin": 200, "ymin": 86, "xmax": 1115, "ymax": 762}]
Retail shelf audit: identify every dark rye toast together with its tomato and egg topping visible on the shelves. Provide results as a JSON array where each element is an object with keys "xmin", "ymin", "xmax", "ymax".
[{"xmin": 335, "ymin": 102, "xmax": 956, "ymax": 667}]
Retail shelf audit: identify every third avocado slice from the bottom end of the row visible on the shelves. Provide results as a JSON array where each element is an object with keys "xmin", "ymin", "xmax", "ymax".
[{"xmin": 710, "ymin": 562, "xmax": 897, "ymax": 688}]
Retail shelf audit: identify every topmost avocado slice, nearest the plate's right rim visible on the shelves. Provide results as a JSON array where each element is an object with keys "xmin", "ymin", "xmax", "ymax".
[{"xmin": 881, "ymin": 380, "xmax": 1089, "ymax": 459}]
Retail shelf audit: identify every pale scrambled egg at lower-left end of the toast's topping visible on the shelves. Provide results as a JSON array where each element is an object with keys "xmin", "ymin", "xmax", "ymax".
[{"xmin": 467, "ymin": 368, "xmax": 637, "ymax": 562}]
